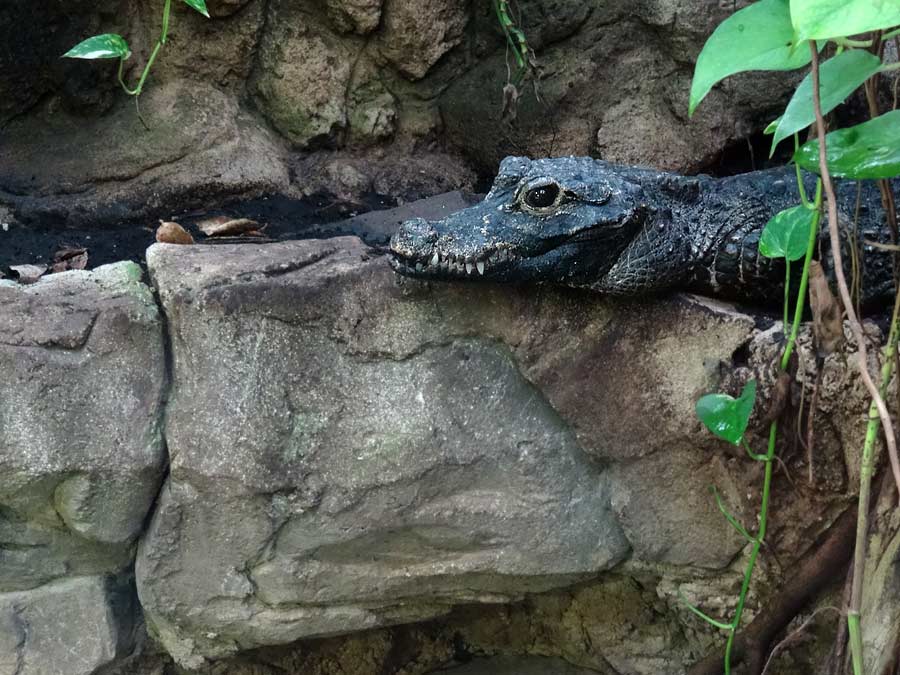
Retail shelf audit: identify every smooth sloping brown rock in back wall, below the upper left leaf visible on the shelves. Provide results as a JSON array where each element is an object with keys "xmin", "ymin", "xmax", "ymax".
[{"xmin": 0, "ymin": 80, "xmax": 288, "ymax": 225}]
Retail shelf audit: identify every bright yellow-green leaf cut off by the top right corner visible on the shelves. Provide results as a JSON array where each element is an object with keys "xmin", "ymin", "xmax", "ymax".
[{"xmin": 790, "ymin": 0, "xmax": 900, "ymax": 42}]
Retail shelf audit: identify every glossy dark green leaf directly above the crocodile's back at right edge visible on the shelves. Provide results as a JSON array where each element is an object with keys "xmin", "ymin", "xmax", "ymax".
[{"xmin": 794, "ymin": 110, "xmax": 900, "ymax": 179}]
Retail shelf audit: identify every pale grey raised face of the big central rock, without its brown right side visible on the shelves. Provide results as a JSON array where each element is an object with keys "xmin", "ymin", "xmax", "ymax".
[{"xmin": 138, "ymin": 239, "xmax": 628, "ymax": 663}]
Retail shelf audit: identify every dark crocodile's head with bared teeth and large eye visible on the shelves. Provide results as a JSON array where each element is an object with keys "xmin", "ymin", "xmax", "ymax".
[{"xmin": 391, "ymin": 157, "xmax": 647, "ymax": 286}]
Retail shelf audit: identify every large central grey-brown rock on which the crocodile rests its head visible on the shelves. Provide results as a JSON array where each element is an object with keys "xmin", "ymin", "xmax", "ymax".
[{"xmin": 137, "ymin": 237, "xmax": 768, "ymax": 666}]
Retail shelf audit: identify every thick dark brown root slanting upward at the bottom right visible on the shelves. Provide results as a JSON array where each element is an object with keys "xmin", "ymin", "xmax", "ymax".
[{"xmin": 688, "ymin": 508, "xmax": 856, "ymax": 675}]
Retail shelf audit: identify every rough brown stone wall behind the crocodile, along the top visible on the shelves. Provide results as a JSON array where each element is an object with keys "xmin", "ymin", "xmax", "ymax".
[{"xmin": 0, "ymin": 0, "xmax": 791, "ymax": 226}]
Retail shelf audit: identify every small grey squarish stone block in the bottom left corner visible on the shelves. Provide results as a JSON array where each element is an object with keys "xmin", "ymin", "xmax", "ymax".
[{"xmin": 0, "ymin": 577, "xmax": 130, "ymax": 675}]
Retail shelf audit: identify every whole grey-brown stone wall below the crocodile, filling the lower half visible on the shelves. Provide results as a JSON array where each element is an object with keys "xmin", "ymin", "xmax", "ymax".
[{"xmin": 0, "ymin": 219, "xmax": 900, "ymax": 675}]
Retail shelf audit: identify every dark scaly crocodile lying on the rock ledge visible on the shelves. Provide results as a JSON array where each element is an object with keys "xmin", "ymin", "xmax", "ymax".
[{"xmin": 390, "ymin": 157, "xmax": 893, "ymax": 303}]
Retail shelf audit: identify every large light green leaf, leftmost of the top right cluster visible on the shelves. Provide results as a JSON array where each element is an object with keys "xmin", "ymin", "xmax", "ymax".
[{"xmin": 688, "ymin": 0, "xmax": 812, "ymax": 115}]
